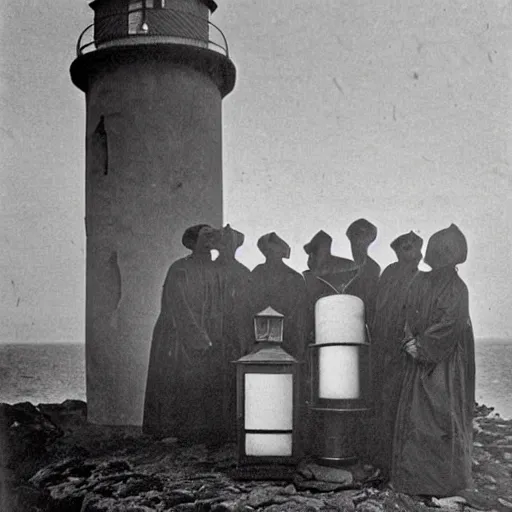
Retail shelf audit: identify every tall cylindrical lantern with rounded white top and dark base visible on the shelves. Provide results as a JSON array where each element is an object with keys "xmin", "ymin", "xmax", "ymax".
[{"xmin": 309, "ymin": 295, "xmax": 371, "ymax": 465}]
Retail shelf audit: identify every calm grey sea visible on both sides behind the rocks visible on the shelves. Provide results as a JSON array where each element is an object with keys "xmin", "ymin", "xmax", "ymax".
[{"xmin": 0, "ymin": 339, "xmax": 512, "ymax": 419}]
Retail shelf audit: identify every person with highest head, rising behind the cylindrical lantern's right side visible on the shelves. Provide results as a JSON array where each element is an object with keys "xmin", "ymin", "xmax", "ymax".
[{"xmin": 346, "ymin": 219, "xmax": 380, "ymax": 326}]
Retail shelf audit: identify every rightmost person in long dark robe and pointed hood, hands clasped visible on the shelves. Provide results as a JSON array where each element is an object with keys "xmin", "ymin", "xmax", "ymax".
[{"xmin": 392, "ymin": 224, "xmax": 475, "ymax": 496}]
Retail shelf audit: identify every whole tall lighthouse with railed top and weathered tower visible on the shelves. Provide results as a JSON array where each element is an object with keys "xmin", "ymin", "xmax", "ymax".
[{"xmin": 70, "ymin": 0, "xmax": 236, "ymax": 425}]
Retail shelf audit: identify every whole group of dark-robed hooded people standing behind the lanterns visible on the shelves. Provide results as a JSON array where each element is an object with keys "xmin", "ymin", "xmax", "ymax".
[{"xmin": 143, "ymin": 219, "xmax": 475, "ymax": 496}]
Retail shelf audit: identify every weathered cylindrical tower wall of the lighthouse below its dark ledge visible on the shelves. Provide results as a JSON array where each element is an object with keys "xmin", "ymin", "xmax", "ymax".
[{"xmin": 86, "ymin": 55, "xmax": 222, "ymax": 425}]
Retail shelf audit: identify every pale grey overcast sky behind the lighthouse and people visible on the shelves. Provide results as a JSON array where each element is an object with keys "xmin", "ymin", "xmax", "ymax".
[{"xmin": 0, "ymin": 0, "xmax": 512, "ymax": 342}]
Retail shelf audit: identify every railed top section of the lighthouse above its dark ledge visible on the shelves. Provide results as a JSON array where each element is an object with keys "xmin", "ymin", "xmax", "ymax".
[{"xmin": 77, "ymin": 0, "xmax": 228, "ymax": 56}]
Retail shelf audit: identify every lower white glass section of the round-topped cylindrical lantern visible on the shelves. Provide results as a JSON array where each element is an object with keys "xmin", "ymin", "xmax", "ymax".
[{"xmin": 318, "ymin": 345, "xmax": 361, "ymax": 399}]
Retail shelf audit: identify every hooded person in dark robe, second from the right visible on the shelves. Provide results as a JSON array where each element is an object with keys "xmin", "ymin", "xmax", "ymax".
[{"xmin": 371, "ymin": 231, "xmax": 423, "ymax": 474}]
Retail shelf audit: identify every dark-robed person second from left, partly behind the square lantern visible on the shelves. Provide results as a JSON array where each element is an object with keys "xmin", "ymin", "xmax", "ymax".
[{"xmin": 212, "ymin": 224, "xmax": 254, "ymax": 443}]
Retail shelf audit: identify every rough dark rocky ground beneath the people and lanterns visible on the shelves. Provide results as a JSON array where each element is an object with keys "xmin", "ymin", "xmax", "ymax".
[{"xmin": 0, "ymin": 400, "xmax": 512, "ymax": 512}]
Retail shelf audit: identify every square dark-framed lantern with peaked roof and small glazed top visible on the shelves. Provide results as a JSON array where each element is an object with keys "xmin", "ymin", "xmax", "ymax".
[{"xmin": 236, "ymin": 307, "xmax": 299, "ymax": 464}]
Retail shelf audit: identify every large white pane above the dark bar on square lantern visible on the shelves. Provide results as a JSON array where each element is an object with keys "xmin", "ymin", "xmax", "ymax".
[{"xmin": 244, "ymin": 373, "xmax": 293, "ymax": 430}]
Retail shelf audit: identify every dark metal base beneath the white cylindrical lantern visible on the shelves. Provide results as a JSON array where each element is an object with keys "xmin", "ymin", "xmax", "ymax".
[{"xmin": 311, "ymin": 407, "xmax": 370, "ymax": 467}]
